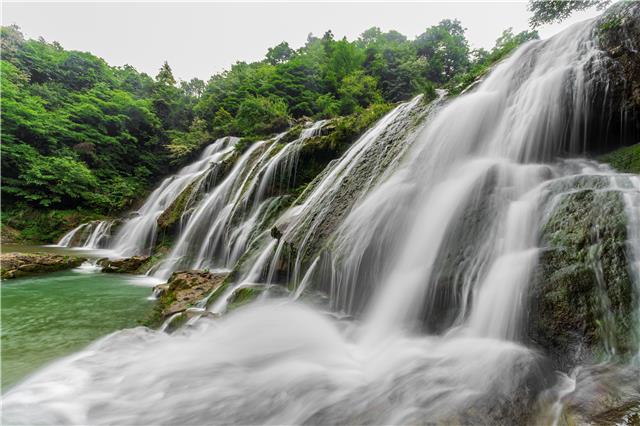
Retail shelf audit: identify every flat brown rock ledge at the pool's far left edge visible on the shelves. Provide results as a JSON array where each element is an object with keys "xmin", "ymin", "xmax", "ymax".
[{"xmin": 0, "ymin": 253, "xmax": 87, "ymax": 280}]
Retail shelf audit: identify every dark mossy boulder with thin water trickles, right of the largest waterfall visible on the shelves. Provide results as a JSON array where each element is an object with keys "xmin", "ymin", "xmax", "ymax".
[{"xmin": 528, "ymin": 188, "xmax": 637, "ymax": 371}]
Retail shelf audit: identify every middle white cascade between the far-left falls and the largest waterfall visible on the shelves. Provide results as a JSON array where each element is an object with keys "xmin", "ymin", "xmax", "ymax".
[{"xmin": 155, "ymin": 120, "xmax": 326, "ymax": 278}]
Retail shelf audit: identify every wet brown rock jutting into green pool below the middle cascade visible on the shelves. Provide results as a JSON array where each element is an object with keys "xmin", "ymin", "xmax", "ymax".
[{"xmin": 154, "ymin": 271, "xmax": 228, "ymax": 318}]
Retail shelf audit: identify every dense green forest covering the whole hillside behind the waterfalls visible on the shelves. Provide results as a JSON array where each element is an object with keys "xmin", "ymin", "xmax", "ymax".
[{"xmin": 1, "ymin": 20, "xmax": 531, "ymax": 241}]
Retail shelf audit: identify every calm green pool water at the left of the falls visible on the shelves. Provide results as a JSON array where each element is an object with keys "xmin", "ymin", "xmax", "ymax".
[{"xmin": 0, "ymin": 271, "xmax": 152, "ymax": 391}]
